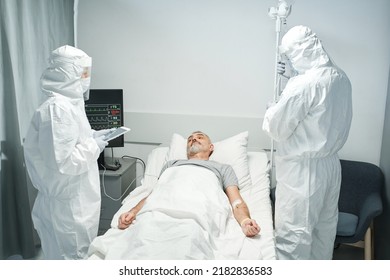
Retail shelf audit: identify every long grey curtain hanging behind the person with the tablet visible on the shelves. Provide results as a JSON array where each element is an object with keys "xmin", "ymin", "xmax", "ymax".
[{"xmin": 0, "ymin": 0, "xmax": 77, "ymax": 259}]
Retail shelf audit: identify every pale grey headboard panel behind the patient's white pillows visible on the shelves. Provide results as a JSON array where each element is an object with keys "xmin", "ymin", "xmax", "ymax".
[{"xmin": 124, "ymin": 112, "xmax": 271, "ymax": 151}]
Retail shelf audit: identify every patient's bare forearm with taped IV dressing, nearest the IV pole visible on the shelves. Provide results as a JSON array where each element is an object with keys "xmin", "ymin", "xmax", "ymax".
[{"xmin": 225, "ymin": 186, "xmax": 260, "ymax": 237}]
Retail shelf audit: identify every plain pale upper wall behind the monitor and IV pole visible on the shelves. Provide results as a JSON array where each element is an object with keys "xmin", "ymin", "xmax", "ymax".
[{"xmin": 78, "ymin": 0, "xmax": 390, "ymax": 164}]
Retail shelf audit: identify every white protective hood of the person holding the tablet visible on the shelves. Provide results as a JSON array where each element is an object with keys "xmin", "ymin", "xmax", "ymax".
[{"xmin": 41, "ymin": 45, "xmax": 92, "ymax": 99}]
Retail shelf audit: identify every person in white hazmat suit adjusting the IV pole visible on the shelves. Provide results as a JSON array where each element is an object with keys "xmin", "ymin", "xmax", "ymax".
[{"xmin": 263, "ymin": 26, "xmax": 352, "ymax": 259}]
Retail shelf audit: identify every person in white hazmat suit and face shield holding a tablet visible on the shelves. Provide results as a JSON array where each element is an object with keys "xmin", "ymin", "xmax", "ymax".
[{"xmin": 24, "ymin": 45, "xmax": 111, "ymax": 259}]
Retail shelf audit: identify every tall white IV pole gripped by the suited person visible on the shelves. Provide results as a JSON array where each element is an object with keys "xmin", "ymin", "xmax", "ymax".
[{"xmin": 268, "ymin": 0, "xmax": 291, "ymax": 187}]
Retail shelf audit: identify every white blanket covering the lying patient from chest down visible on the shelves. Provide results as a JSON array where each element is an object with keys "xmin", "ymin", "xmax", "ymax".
[{"xmin": 90, "ymin": 166, "xmax": 261, "ymax": 260}]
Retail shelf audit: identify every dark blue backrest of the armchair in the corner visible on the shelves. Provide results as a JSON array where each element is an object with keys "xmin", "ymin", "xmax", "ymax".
[{"xmin": 339, "ymin": 160, "xmax": 384, "ymax": 216}]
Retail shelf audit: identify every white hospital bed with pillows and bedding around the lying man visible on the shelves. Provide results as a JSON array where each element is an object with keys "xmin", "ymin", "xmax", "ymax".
[{"xmin": 89, "ymin": 132, "xmax": 276, "ymax": 260}]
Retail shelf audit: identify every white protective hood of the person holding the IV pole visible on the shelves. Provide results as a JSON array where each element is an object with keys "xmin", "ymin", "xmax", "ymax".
[{"xmin": 279, "ymin": 25, "xmax": 332, "ymax": 74}]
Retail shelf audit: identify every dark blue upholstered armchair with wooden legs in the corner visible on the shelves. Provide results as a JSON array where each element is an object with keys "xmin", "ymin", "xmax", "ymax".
[{"xmin": 335, "ymin": 160, "xmax": 384, "ymax": 259}]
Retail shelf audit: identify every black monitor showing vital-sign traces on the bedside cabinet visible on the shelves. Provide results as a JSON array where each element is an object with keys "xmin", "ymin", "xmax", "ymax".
[{"xmin": 85, "ymin": 89, "xmax": 124, "ymax": 147}]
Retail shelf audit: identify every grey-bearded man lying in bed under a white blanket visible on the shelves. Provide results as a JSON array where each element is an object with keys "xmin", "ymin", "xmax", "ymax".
[{"xmin": 88, "ymin": 132, "xmax": 260, "ymax": 259}]
